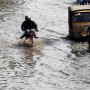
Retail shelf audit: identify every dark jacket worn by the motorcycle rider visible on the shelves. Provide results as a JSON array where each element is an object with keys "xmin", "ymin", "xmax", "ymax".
[{"xmin": 21, "ymin": 19, "xmax": 38, "ymax": 31}]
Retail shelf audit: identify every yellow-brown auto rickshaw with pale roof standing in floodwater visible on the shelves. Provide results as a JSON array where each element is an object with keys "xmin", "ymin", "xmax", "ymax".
[{"xmin": 68, "ymin": 5, "xmax": 90, "ymax": 39}]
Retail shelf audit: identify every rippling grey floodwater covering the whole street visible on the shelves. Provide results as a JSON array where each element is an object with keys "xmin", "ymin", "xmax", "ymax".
[{"xmin": 0, "ymin": 0, "xmax": 90, "ymax": 90}]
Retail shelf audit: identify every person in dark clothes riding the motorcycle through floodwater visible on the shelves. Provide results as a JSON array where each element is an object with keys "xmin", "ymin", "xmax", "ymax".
[{"xmin": 20, "ymin": 16, "xmax": 38, "ymax": 39}]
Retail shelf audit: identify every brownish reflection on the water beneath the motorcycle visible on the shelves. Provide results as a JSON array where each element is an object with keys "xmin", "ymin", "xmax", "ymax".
[{"xmin": 18, "ymin": 38, "xmax": 42, "ymax": 68}]
